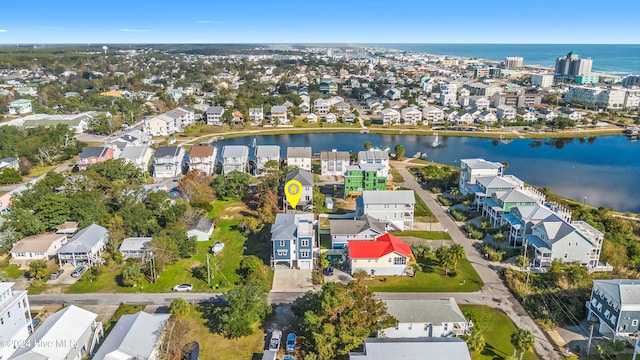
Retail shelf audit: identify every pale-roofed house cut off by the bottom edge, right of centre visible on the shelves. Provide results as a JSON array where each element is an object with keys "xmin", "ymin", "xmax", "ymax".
[{"xmin": 349, "ymin": 337, "xmax": 471, "ymax": 360}]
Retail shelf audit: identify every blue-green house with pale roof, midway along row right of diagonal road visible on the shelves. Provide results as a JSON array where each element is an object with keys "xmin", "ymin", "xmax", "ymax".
[{"xmin": 482, "ymin": 187, "xmax": 545, "ymax": 227}]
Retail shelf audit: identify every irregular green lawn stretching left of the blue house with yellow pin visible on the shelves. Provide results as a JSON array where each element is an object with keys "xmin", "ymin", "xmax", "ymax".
[{"xmin": 68, "ymin": 201, "xmax": 272, "ymax": 293}]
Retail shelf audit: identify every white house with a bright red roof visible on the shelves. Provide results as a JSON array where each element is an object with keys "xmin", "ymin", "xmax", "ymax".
[{"xmin": 347, "ymin": 234, "xmax": 415, "ymax": 276}]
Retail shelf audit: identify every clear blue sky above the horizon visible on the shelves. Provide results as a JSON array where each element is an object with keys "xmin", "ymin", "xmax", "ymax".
[{"xmin": 0, "ymin": 0, "xmax": 640, "ymax": 44}]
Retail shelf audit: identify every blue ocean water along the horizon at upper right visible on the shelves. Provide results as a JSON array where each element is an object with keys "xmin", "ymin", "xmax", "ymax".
[{"xmin": 363, "ymin": 44, "xmax": 640, "ymax": 75}]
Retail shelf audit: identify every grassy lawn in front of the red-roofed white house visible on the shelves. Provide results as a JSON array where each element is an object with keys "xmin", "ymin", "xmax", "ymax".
[{"xmin": 365, "ymin": 257, "xmax": 483, "ymax": 292}]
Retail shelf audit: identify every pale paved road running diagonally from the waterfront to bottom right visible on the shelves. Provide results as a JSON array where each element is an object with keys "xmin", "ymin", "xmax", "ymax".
[{"xmin": 392, "ymin": 162, "xmax": 564, "ymax": 360}]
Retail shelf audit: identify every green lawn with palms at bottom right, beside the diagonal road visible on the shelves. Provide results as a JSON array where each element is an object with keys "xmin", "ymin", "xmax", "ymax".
[{"xmin": 460, "ymin": 305, "xmax": 539, "ymax": 360}]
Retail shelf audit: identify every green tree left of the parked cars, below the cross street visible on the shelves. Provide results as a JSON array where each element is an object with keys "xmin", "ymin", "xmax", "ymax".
[{"xmin": 219, "ymin": 279, "xmax": 271, "ymax": 338}]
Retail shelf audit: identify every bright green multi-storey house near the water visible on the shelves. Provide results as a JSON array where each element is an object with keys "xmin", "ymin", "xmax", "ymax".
[{"xmin": 344, "ymin": 164, "xmax": 388, "ymax": 198}]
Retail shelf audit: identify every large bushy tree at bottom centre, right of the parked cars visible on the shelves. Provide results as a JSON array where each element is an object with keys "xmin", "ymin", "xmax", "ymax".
[{"xmin": 292, "ymin": 281, "xmax": 398, "ymax": 360}]
